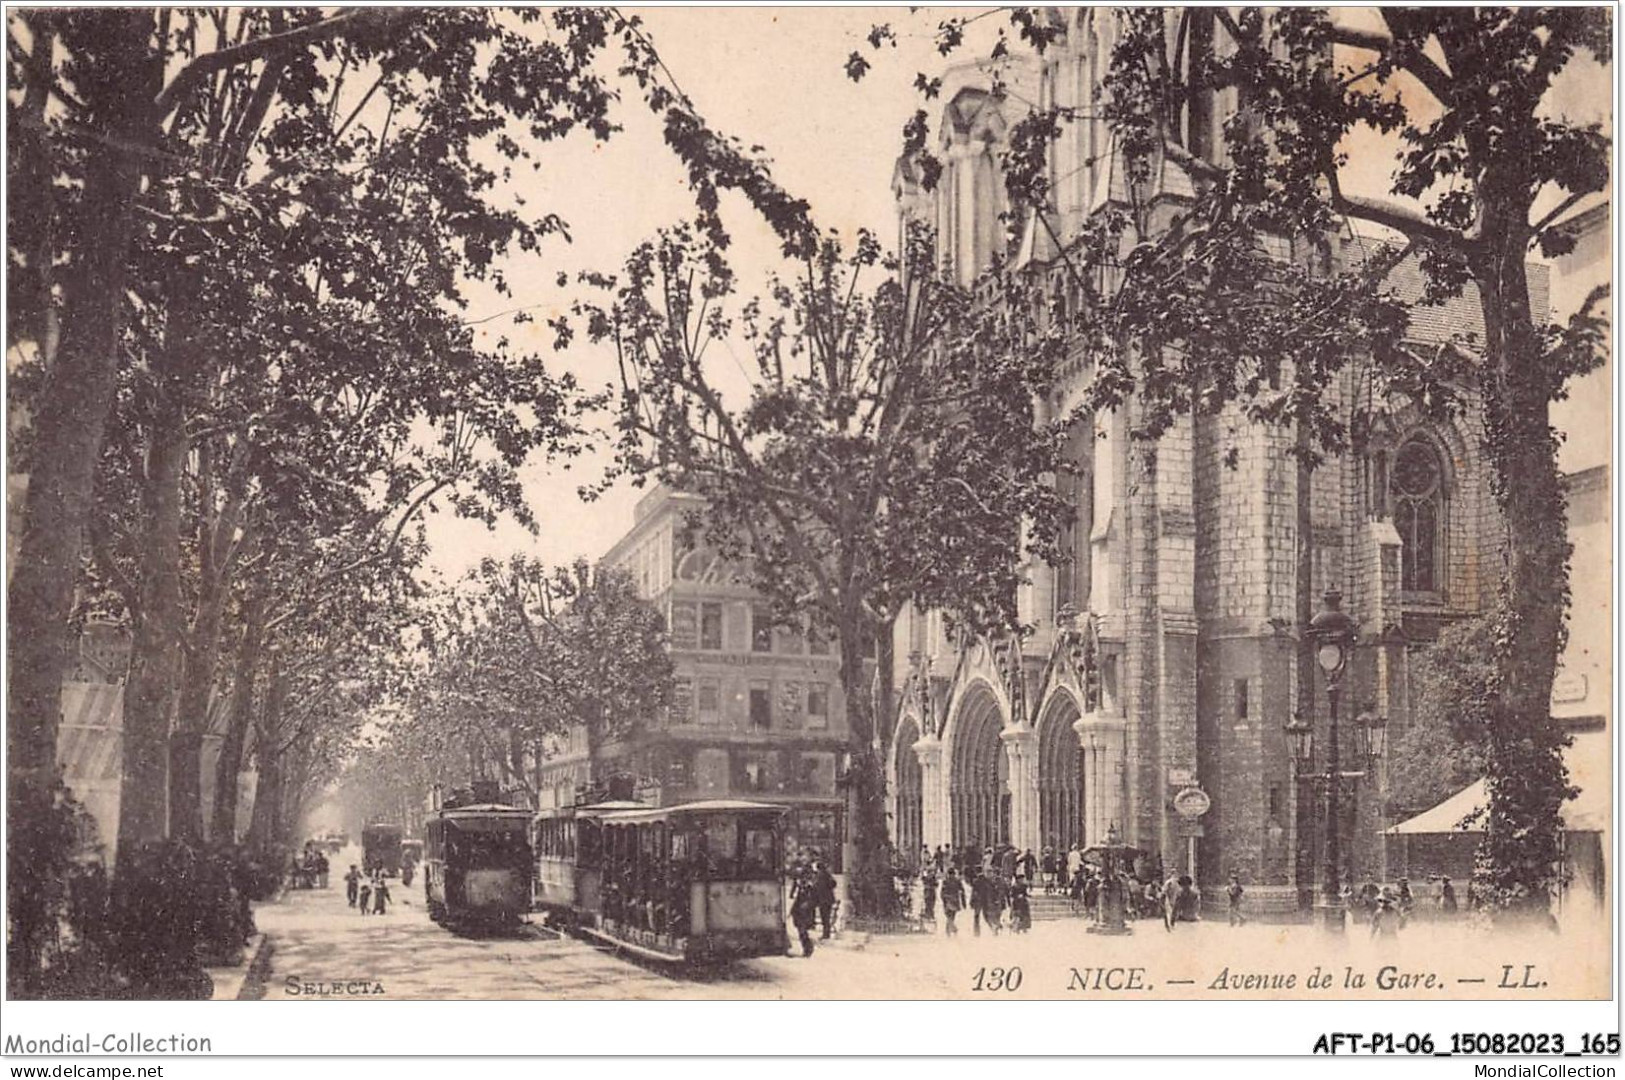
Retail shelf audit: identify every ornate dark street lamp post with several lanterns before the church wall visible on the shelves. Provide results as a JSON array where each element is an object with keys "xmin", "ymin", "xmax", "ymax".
[{"xmin": 1285, "ymin": 588, "xmax": 1388, "ymax": 934}]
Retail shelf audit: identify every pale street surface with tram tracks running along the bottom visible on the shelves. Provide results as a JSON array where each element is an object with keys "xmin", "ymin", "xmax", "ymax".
[{"xmin": 247, "ymin": 861, "xmax": 1607, "ymax": 1000}]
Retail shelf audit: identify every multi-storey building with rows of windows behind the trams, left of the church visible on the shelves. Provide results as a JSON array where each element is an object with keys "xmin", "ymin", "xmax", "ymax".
[{"xmin": 543, "ymin": 487, "xmax": 847, "ymax": 861}]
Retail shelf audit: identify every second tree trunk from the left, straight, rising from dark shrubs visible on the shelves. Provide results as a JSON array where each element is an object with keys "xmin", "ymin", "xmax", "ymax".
[{"xmin": 119, "ymin": 390, "xmax": 187, "ymax": 848}]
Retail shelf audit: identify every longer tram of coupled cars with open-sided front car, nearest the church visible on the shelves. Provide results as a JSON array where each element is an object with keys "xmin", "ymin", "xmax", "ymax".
[{"xmin": 533, "ymin": 801, "xmax": 788, "ymax": 963}]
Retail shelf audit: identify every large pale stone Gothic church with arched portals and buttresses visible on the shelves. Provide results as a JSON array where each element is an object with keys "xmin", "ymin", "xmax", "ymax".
[{"xmin": 889, "ymin": 8, "xmax": 1514, "ymax": 906}]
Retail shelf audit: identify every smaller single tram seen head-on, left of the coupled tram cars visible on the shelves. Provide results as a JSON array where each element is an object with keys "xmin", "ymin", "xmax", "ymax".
[{"xmin": 423, "ymin": 804, "xmax": 533, "ymax": 926}]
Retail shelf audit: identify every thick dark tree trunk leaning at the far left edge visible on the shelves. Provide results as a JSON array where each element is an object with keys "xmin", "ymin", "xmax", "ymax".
[{"xmin": 7, "ymin": 8, "xmax": 163, "ymax": 983}]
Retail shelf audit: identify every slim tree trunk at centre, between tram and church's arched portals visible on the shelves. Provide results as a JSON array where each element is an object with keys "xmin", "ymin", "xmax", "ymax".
[{"xmin": 839, "ymin": 612, "xmax": 897, "ymax": 918}]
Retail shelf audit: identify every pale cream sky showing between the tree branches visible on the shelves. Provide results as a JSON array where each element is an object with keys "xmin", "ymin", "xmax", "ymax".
[{"xmin": 429, "ymin": 8, "xmax": 1610, "ymax": 578}]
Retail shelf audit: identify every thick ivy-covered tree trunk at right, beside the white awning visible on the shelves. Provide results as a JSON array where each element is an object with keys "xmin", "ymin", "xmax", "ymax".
[{"xmin": 1474, "ymin": 232, "xmax": 1570, "ymax": 916}]
